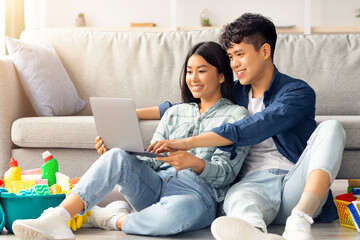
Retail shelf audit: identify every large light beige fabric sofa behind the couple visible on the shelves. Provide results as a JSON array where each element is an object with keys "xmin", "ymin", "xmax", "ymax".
[{"xmin": 0, "ymin": 28, "xmax": 360, "ymax": 179}]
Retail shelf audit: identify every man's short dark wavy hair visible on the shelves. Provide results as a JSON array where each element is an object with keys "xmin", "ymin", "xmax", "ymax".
[{"xmin": 220, "ymin": 13, "xmax": 277, "ymax": 60}]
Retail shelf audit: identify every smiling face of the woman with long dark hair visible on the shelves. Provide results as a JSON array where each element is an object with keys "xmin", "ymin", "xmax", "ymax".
[{"xmin": 186, "ymin": 55, "xmax": 224, "ymax": 103}]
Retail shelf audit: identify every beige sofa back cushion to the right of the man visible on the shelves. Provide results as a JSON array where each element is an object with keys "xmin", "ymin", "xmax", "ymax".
[{"xmin": 274, "ymin": 34, "xmax": 360, "ymax": 115}]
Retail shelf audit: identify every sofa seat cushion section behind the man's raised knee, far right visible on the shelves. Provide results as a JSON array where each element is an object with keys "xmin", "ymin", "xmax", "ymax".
[{"xmin": 315, "ymin": 116, "xmax": 360, "ymax": 149}]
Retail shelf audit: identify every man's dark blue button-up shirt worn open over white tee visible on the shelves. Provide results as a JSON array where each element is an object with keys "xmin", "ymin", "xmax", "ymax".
[{"xmin": 159, "ymin": 67, "xmax": 338, "ymax": 222}]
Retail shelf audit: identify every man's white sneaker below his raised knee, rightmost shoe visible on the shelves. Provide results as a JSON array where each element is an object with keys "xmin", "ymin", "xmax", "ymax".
[{"xmin": 283, "ymin": 210, "xmax": 315, "ymax": 240}]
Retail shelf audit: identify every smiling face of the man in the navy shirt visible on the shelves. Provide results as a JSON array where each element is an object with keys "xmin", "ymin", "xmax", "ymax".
[{"xmin": 227, "ymin": 42, "xmax": 266, "ymax": 85}]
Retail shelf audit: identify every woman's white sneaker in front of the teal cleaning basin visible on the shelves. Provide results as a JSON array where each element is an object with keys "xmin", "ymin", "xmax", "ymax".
[{"xmin": 12, "ymin": 208, "xmax": 75, "ymax": 240}]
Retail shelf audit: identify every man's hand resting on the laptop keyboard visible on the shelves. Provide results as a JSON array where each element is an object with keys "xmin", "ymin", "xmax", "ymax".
[{"xmin": 147, "ymin": 138, "xmax": 191, "ymax": 153}]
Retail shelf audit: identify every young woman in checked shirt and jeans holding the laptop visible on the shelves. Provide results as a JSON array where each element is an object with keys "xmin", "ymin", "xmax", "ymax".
[{"xmin": 13, "ymin": 42, "xmax": 249, "ymax": 239}]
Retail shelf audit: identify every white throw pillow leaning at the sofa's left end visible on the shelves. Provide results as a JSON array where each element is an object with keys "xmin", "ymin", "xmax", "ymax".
[{"xmin": 6, "ymin": 37, "xmax": 86, "ymax": 116}]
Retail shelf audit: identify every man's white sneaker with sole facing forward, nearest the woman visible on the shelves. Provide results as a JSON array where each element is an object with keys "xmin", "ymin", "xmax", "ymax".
[{"xmin": 211, "ymin": 217, "xmax": 284, "ymax": 240}]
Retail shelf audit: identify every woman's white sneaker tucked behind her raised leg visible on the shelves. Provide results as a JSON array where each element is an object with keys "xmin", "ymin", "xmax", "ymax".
[{"xmin": 86, "ymin": 201, "xmax": 130, "ymax": 230}]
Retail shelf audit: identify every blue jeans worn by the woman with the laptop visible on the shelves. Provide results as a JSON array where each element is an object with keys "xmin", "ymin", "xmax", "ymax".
[{"xmin": 71, "ymin": 149, "xmax": 217, "ymax": 235}]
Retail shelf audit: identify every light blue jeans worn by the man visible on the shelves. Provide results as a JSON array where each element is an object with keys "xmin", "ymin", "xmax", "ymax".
[{"xmin": 223, "ymin": 120, "xmax": 345, "ymax": 232}]
